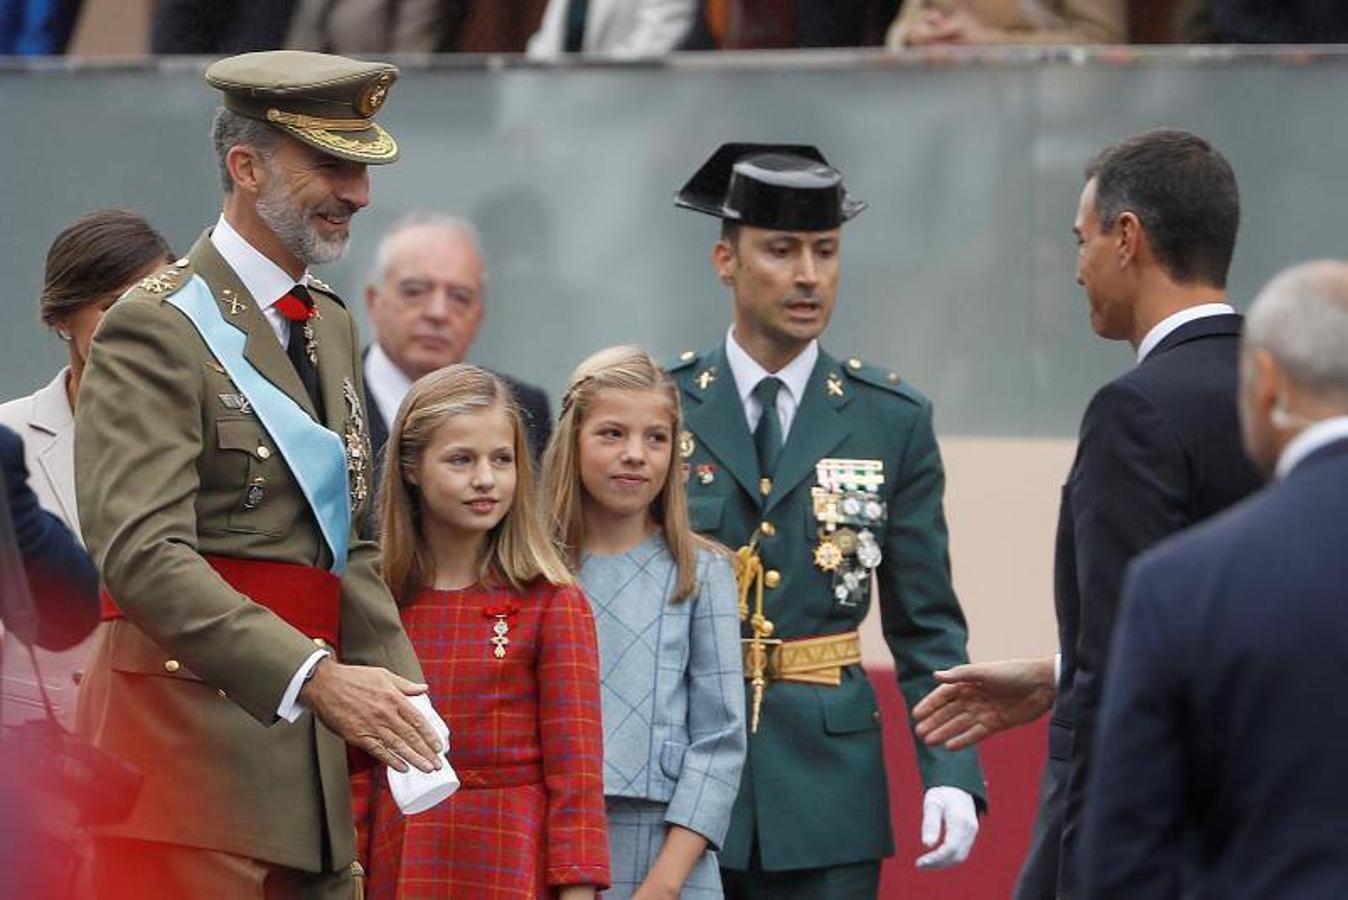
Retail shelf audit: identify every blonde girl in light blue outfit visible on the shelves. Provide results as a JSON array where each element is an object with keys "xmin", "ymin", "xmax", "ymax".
[{"xmin": 543, "ymin": 346, "xmax": 745, "ymax": 900}]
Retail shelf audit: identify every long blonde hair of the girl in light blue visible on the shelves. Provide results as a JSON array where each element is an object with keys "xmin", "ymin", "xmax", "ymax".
[{"xmin": 543, "ymin": 345, "xmax": 720, "ymax": 602}]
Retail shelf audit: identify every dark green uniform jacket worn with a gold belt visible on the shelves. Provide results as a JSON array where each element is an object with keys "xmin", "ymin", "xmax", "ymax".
[{"xmin": 671, "ymin": 346, "xmax": 985, "ymax": 870}]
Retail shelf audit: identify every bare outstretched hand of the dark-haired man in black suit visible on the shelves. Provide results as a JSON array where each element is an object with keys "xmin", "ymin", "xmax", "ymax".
[{"xmin": 913, "ymin": 656, "xmax": 1057, "ymax": 750}]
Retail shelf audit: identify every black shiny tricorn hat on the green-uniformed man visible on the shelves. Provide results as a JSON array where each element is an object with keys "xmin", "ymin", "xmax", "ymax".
[{"xmin": 674, "ymin": 144, "xmax": 865, "ymax": 232}]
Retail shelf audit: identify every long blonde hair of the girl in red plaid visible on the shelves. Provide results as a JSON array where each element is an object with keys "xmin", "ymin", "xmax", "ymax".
[{"xmin": 379, "ymin": 364, "xmax": 574, "ymax": 604}]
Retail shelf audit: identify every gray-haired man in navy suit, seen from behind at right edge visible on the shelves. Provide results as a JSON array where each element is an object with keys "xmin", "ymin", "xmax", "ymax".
[{"xmin": 1081, "ymin": 255, "xmax": 1348, "ymax": 900}]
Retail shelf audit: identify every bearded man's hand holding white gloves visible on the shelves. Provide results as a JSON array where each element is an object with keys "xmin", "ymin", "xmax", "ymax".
[{"xmin": 299, "ymin": 659, "xmax": 443, "ymax": 772}]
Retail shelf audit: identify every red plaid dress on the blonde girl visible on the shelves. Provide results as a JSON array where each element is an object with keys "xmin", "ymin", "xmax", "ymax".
[{"xmin": 353, "ymin": 579, "xmax": 608, "ymax": 900}]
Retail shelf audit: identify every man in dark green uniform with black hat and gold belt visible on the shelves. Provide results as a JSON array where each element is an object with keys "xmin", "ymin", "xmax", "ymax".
[{"xmin": 671, "ymin": 144, "xmax": 984, "ymax": 900}]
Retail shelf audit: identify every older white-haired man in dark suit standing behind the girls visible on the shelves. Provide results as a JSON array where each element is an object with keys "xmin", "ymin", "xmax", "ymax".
[{"xmin": 364, "ymin": 213, "xmax": 553, "ymax": 482}]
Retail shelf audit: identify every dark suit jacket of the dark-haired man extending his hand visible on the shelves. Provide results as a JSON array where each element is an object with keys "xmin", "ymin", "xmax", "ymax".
[{"xmin": 1035, "ymin": 315, "xmax": 1259, "ymax": 900}]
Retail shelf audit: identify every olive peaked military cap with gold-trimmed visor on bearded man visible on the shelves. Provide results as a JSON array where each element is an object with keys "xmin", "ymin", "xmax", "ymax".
[{"xmin": 206, "ymin": 50, "xmax": 398, "ymax": 164}]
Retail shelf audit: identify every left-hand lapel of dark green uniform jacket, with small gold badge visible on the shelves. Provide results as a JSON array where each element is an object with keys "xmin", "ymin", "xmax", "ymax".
[{"xmin": 683, "ymin": 346, "xmax": 759, "ymax": 501}]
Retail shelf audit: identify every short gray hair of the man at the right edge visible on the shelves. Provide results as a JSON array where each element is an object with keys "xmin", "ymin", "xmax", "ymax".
[{"xmin": 1244, "ymin": 260, "xmax": 1348, "ymax": 401}]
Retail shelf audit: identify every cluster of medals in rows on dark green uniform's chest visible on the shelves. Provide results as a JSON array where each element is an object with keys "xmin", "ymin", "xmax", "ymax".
[{"xmin": 810, "ymin": 459, "xmax": 886, "ymax": 606}]
